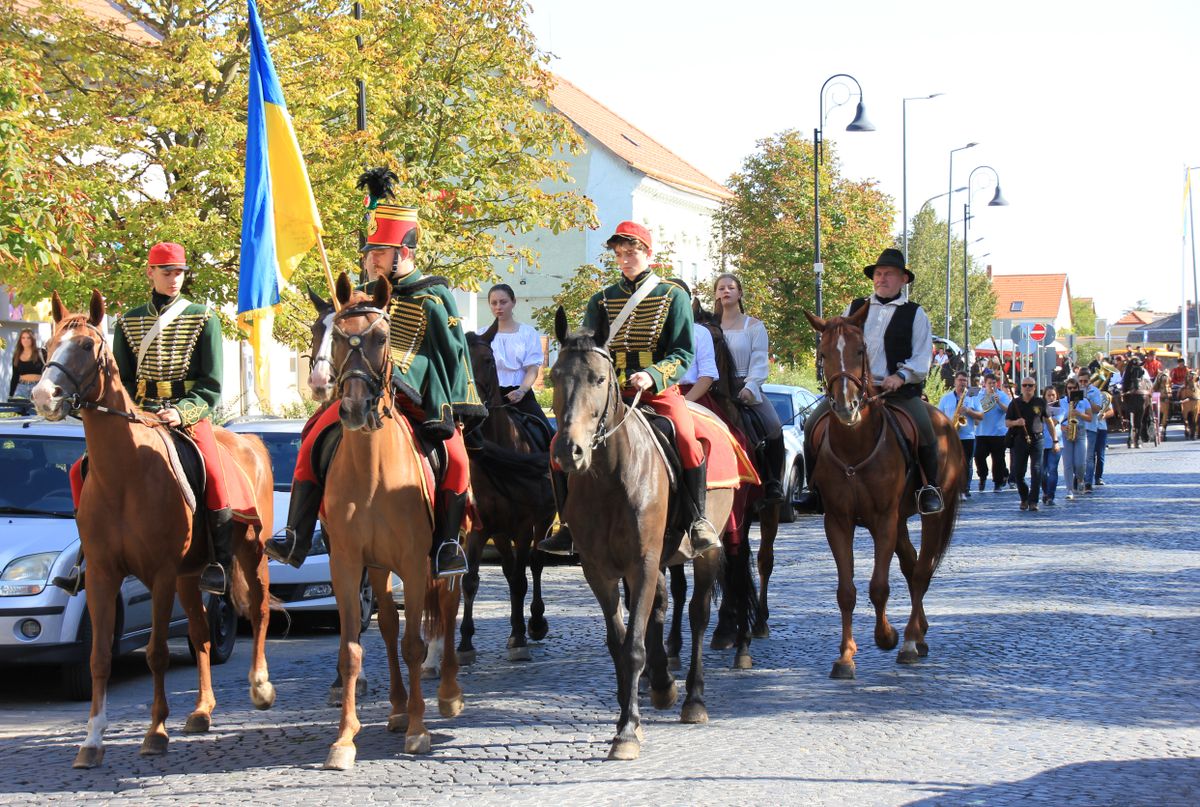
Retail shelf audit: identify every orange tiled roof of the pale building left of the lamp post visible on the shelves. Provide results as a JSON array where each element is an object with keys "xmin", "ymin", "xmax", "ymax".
[{"xmin": 550, "ymin": 76, "xmax": 733, "ymax": 199}]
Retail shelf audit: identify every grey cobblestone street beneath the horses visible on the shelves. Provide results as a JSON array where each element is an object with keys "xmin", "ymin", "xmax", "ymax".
[{"xmin": 0, "ymin": 426, "xmax": 1200, "ymax": 806}]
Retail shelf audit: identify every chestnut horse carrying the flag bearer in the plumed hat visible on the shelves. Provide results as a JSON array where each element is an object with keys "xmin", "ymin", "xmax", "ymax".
[{"xmin": 324, "ymin": 273, "xmax": 463, "ymax": 770}]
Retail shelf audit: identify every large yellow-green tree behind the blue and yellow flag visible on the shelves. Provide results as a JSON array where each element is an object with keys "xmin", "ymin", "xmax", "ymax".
[{"xmin": 0, "ymin": 0, "xmax": 594, "ymax": 343}]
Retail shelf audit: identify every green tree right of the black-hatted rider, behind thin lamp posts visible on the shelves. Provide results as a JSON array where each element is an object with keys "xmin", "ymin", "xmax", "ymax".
[{"xmin": 898, "ymin": 205, "xmax": 996, "ymax": 349}]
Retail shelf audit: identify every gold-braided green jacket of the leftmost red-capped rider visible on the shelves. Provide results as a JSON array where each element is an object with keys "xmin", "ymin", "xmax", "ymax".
[{"xmin": 113, "ymin": 293, "xmax": 221, "ymax": 426}]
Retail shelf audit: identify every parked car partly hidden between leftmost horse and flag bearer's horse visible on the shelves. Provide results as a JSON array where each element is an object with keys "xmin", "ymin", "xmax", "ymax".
[{"xmin": 224, "ymin": 417, "xmax": 376, "ymax": 630}]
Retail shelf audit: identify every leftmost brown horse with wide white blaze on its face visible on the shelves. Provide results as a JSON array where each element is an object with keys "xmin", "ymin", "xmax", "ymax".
[{"xmin": 34, "ymin": 291, "xmax": 275, "ymax": 767}]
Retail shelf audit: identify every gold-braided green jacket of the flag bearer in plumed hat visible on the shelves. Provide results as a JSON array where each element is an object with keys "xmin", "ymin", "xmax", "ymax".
[{"xmin": 372, "ymin": 270, "xmax": 487, "ymax": 440}]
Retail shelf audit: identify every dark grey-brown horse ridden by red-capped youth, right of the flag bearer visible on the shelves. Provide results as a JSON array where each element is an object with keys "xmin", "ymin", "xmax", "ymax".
[{"xmin": 551, "ymin": 307, "xmax": 733, "ymax": 759}]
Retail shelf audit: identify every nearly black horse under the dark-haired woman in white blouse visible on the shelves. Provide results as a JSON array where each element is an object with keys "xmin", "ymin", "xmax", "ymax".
[{"xmin": 458, "ymin": 334, "xmax": 554, "ymax": 664}]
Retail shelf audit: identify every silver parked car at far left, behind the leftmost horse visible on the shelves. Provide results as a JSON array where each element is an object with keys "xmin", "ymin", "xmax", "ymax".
[{"xmin": 0, "ymin": 417, "xmax": 238, "ymax": 700}]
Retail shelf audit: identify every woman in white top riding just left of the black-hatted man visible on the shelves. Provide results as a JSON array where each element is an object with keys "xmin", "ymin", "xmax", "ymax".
[{"xmin": 713, "ymin": 273, "xmax": 785, "ymax": 504}]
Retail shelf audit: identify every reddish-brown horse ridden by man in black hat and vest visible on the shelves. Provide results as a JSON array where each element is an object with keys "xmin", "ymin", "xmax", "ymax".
[{"xmin": 804, "ymin": 305, "xmax": 968, "ymax": 679}]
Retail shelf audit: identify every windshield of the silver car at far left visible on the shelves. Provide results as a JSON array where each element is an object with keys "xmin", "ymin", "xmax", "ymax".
[{"xmin": 0, "ymin": 435, "xmax": 84, "ymax": 516}]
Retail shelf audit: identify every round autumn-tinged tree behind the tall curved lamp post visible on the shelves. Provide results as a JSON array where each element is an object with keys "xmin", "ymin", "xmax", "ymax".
[{"xmin": 714, "ymin": 131, "xmax": 895, "ymax": 366}]
